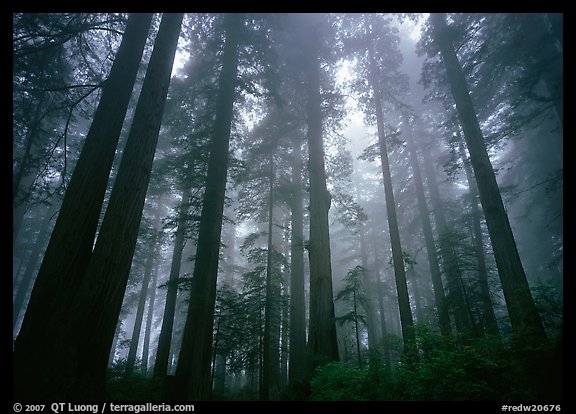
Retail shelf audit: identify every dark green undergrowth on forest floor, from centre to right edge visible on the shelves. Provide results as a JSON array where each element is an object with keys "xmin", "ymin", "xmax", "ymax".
[{"xmin": 310, "ymin": 325, "xmax": 563, "ymax": 401}]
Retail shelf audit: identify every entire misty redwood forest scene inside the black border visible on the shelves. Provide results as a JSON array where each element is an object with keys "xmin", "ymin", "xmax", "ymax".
[{"xmin": 12, "ymin": 13, "xmax": 563, "ymax": 403}]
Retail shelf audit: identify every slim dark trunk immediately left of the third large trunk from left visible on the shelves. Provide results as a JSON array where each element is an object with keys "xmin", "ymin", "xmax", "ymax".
[{"xmin": 154, "ymin": 185, "xmax": 192, "ymax": 378}]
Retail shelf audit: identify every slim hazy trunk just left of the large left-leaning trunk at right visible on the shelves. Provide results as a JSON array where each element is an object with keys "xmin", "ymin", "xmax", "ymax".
[{"xmin": 458, "ymin": 134, "xmax": 500, "ymax": 336}]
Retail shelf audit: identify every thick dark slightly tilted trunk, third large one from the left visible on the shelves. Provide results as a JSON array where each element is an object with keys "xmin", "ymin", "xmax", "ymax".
[{"xmin": 175, "ymin": 14, "xmax": 243, "ymax": 400}]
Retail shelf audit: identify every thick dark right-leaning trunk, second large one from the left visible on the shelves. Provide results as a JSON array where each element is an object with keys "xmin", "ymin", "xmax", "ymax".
[{"xmin": 32, "ymin": 13, "xmax": 183, "ymax": 399}]
